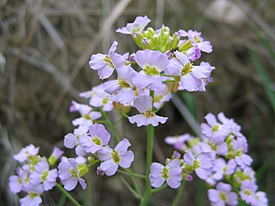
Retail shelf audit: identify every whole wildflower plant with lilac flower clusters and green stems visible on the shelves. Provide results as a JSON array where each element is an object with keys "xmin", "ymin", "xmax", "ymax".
[{"xmin": 9, "ymin": 16, "xmax": 268, "ymax": 206}]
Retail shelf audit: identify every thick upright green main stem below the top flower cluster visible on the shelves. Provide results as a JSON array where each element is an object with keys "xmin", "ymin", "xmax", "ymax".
[{"xmin": 140, "ymin": 124, "xmax": 154, "ymax": 206}]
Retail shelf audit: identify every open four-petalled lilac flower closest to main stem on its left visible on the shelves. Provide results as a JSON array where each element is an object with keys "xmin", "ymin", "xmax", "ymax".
[{"xmin": 98, "ymin": 138, "xmax": 134, "ymax": 176}]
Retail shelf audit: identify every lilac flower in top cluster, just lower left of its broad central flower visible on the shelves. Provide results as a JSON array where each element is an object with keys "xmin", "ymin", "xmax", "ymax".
[{"xmin": 104, "ymin": 66, "xmax": 141, "ymax": 105}]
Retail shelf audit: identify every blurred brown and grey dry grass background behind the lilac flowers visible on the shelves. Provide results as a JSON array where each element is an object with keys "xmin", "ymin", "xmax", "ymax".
[{"xmin": 0, "ymin": 0, "xmax": 275, "ymax": 206}]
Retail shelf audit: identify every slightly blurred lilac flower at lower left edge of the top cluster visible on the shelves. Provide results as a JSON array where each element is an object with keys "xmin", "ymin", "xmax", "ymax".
[{"xmin": 80, "ymin": 84, "xmax": 113, "ymax": 112}]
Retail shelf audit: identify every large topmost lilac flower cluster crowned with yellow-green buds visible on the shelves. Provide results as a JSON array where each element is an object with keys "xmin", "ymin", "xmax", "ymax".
[{"xmin": 86, "ymin": 16, "xmax": 215, "ymax": 127}]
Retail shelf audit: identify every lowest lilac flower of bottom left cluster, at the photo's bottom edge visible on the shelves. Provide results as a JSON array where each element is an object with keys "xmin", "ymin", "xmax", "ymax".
[{"xmin": 20, "ymin": 185, "xmax": 43, "ymax": 206}]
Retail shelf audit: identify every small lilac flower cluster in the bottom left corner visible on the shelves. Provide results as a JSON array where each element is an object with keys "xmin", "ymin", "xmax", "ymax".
[{"xmin": 9, "ymin": 144, "xmax": 63, "ymax": 206}]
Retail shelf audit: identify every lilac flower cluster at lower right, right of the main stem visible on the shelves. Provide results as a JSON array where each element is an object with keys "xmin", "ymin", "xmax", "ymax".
[{"xmin": 158, "ymin": 113, "xmax": 267, "ymax": 206}]
